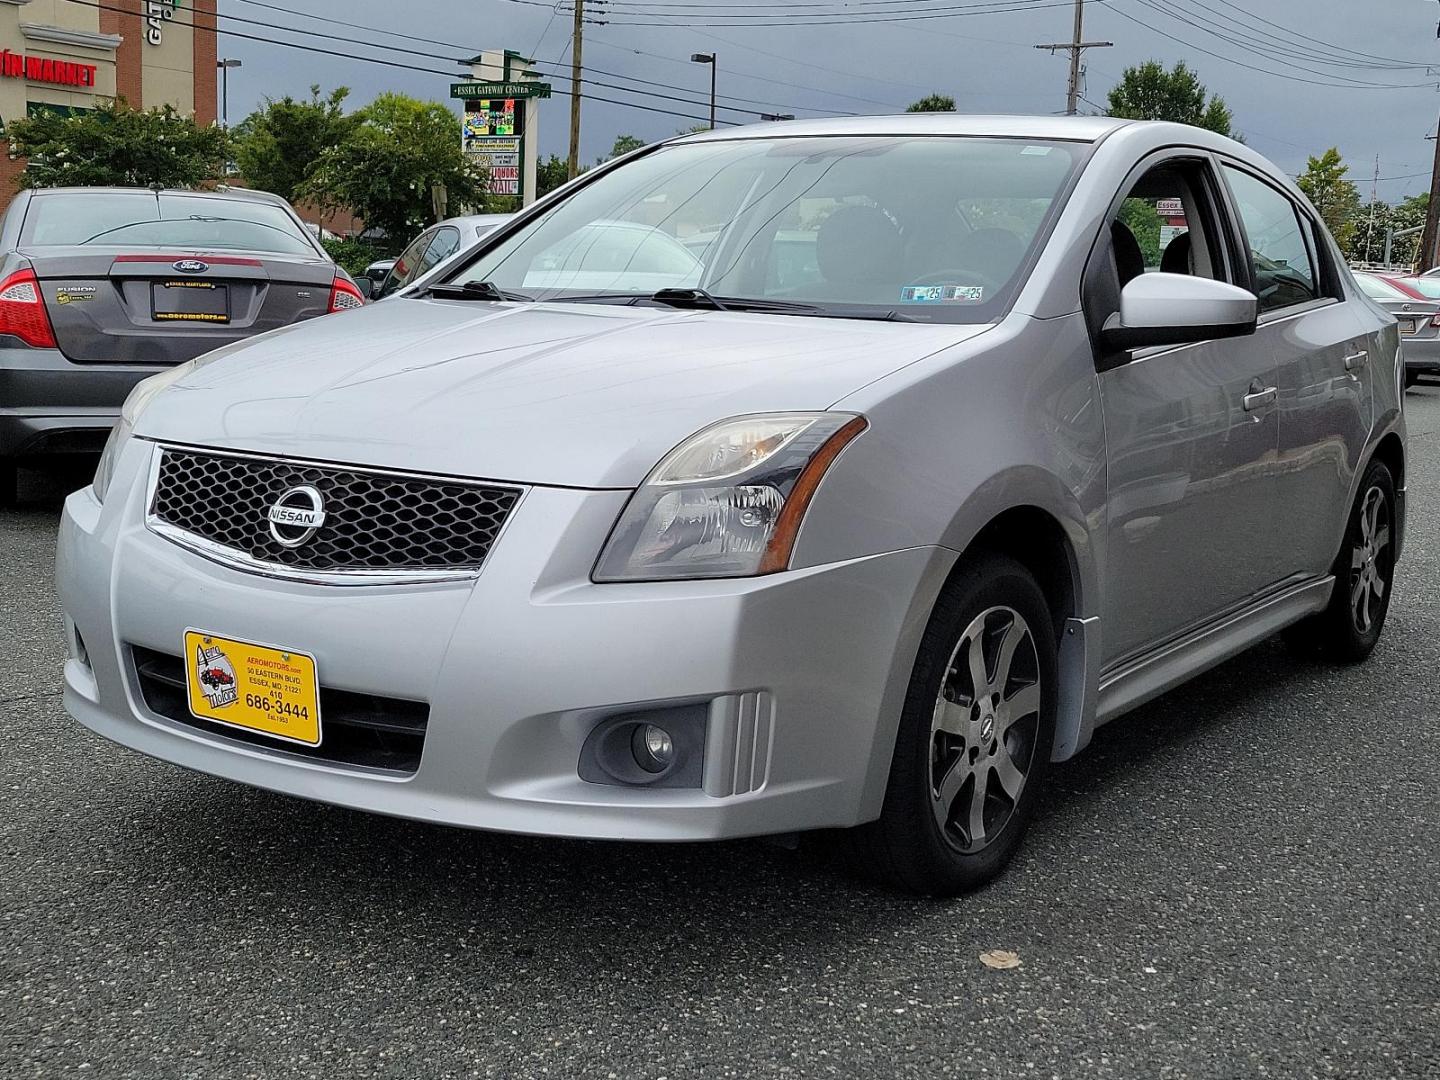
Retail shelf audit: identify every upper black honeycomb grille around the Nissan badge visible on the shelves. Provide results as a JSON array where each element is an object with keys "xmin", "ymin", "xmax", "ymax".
[{"xmin": 150, "ymin": 448, "xmax": 520, "ymax": 572}]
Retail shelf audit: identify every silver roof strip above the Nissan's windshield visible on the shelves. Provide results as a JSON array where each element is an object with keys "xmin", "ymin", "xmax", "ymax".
[{"xmin": 683, "ymin": 112, "xmax": 1145, "ymax": 143}]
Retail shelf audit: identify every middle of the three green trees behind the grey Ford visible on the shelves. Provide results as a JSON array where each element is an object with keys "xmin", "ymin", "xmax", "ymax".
[{"xmin": 233, "ymin": 86, "xmax": 360, "ymax": 202}]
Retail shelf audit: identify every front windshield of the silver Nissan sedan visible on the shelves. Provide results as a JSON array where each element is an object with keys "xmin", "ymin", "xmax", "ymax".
[{"xmin": 449, "ymin": 137, "xmax": 1086, "ymax": 323}]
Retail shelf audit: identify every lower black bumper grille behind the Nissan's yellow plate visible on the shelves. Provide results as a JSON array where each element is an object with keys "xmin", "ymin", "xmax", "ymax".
[{"xmin": 130, "ymin": 645, "xmax": 431, "ymax": 773}]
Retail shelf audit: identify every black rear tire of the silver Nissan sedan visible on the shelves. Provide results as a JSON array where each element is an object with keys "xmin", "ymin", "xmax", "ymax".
[{"xmin": 1283, "ymin": 461, "xmax": 1395, "ymax": 664}]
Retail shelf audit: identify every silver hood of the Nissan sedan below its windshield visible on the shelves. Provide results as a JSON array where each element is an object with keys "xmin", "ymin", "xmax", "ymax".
[{"xmin": 137, "ymin": 298, "xmax": 988, "ymax": 488}]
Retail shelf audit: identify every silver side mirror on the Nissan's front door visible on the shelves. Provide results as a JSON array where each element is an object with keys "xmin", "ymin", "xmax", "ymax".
[{"xmin": 1100, "ymin": 274, "xmax": 1260, "ymax": 353}]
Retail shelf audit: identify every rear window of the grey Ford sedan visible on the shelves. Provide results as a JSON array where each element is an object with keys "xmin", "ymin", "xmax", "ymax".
[{"xmin": 20, "ymin": 192, "xmax": 315, "ymax": 256}]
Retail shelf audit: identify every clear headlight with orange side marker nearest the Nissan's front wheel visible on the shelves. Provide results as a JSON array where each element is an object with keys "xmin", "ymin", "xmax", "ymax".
[{"xmin": 595, "ymin": 412, "xmax": 865, "ymax": 582}]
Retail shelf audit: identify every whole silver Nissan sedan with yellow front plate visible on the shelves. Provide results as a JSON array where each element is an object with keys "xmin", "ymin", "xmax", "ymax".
[{"xmin": 59, "ymin": 115, "xmax": 1405, "ymax": 894}]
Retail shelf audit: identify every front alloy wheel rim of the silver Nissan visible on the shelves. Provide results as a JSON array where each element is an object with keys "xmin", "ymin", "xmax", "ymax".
[{"xmin": 929, "ymin": 606, "xmax": 1041, "ymax": 854}]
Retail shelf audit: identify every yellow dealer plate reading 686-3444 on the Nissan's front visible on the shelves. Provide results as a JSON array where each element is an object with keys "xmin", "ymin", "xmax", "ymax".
[{"xmin": 184, "ymin": 629, "xmax": 320, "ymax": 746}]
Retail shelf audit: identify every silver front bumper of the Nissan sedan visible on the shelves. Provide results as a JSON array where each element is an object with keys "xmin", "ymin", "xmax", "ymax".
[{"xmin": 58, "ymin": 439, "xmax": 955, "ymax": 840}]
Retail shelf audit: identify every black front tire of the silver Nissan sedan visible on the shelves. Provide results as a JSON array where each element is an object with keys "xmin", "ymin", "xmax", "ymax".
[{"xmin": 848, "ymin": 554, "xmax": 1058, "ymax": 896}]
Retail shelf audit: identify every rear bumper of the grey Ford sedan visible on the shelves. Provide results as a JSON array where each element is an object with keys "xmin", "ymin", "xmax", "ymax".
[{"xmin": 0, "ymin": 348, "xmax": 166, "ymax": 458}]
